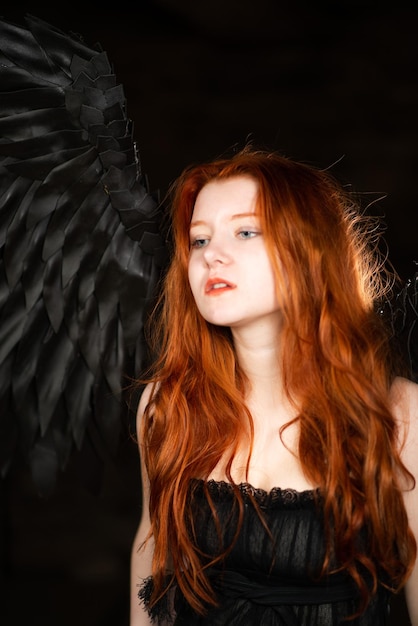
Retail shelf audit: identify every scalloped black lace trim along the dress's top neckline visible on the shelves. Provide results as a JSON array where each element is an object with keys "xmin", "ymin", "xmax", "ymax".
[{"xmin": 194, "ymin": 478, "xmax": 320, "ymax": 508}]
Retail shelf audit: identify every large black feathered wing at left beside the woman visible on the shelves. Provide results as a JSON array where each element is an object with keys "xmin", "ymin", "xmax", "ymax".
[{"xmin": 0, "ymin": 17, "xmax": 165, "ymax": 494}]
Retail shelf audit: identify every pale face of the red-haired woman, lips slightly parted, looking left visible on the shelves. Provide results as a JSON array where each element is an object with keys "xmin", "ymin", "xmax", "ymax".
[{"xmin": 189, "ymin": 176, "xmax": 280, "ymax": 329}]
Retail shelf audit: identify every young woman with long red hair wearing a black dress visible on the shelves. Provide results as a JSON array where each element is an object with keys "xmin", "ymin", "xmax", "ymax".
[{"xmin": 131, "ymin": 149, "xmax": 418, "ymax": 626}]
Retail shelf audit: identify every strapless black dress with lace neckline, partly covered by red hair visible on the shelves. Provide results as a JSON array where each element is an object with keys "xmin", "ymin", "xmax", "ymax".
[{"xmin": 139, "ymin": 480, "xmax": 390, "ymax": 626}]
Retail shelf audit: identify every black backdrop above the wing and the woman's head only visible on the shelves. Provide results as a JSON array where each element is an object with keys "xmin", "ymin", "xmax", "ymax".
[{"xmin": 4, "ymin": 0, "xmax": 418, "ymax": 276}]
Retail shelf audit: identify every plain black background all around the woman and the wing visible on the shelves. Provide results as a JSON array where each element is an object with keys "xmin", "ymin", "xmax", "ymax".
[{"xmin": 0, "ymin": 0, "xmax": 418, "ymax": 626}]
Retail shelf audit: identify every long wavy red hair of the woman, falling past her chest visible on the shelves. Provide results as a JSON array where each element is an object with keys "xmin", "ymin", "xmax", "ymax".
[{"xmin": 141, "ymin": 149, "xmax": 416, "ymax": 611}]
